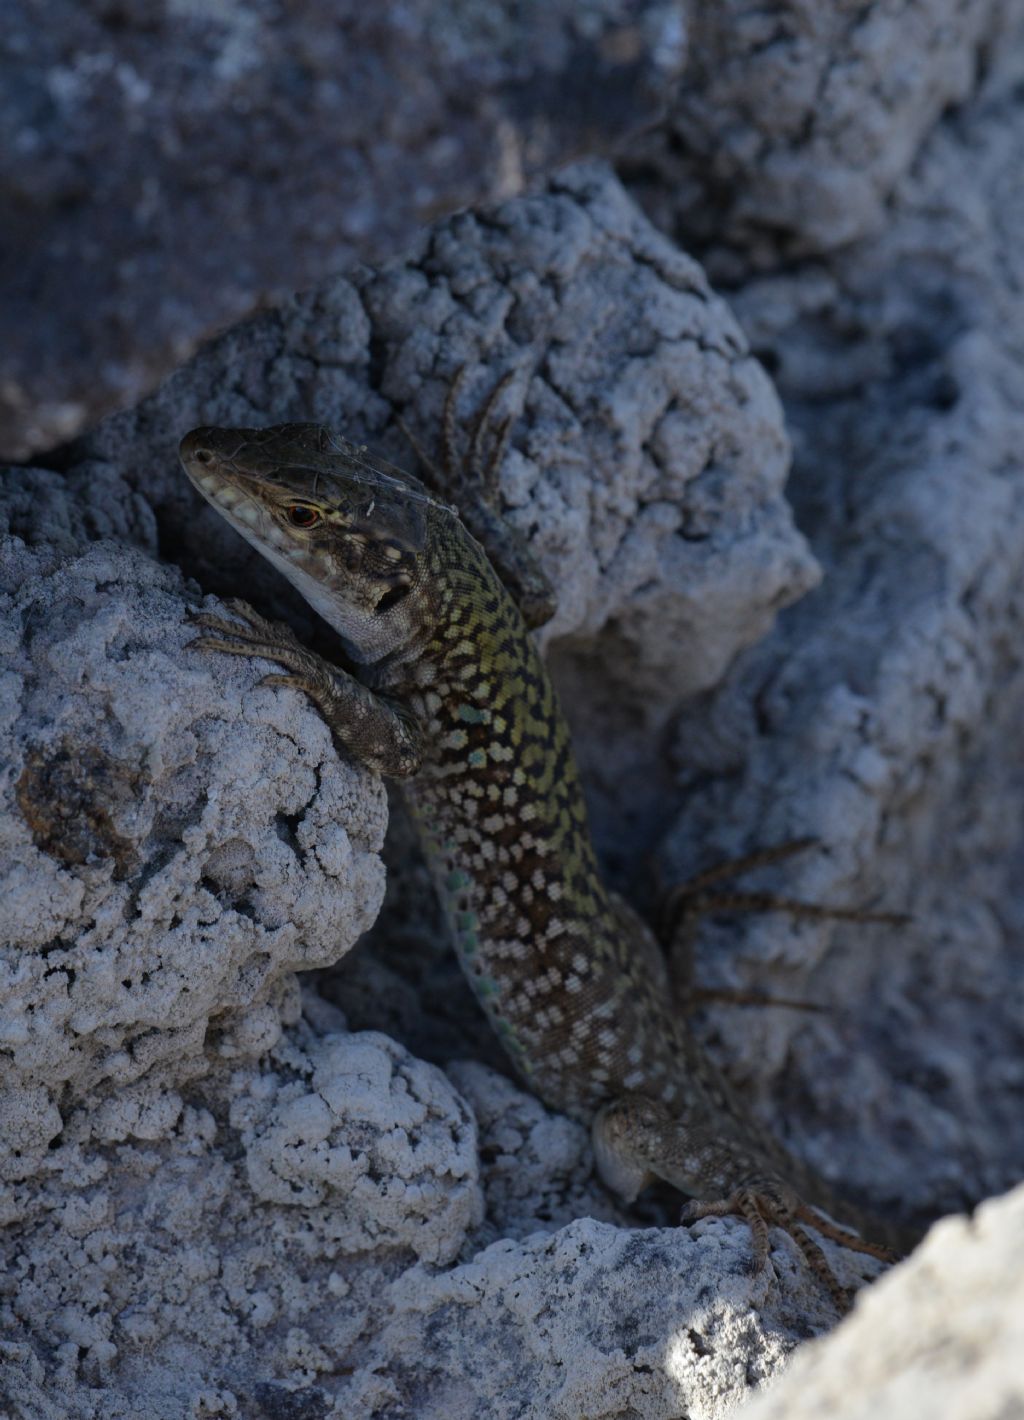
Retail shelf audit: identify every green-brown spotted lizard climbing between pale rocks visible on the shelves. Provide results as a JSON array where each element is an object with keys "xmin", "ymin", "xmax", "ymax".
[{"xmin": 179, "ymin": 376, "xmax": 896, "ymax": 1312}]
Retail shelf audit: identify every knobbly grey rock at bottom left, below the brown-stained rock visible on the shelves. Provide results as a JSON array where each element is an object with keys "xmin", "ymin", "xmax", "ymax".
[{"xmin": 0, "ymin": 1000, "xmax": 480, "ymax": 1420}]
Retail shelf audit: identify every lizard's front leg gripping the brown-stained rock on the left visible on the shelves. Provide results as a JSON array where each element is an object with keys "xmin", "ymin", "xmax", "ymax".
[{"xmin": 189, "ymin": 598, "xmax": 423, "ymax": 778}]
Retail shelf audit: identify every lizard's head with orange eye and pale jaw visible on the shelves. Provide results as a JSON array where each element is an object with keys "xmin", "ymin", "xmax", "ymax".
[{"xmin": 179, "ymin": 425, "xmax": 450, "ymax": 662}]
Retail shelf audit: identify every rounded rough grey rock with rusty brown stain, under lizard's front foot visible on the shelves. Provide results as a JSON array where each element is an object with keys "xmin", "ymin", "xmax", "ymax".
[{"xmin": 0, "ymin": 533, "xmax": 385, "ymax": 1187}]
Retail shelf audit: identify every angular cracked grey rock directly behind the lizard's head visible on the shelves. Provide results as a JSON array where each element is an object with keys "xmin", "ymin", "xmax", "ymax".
[{"xmin": 68, "ymin": 163, "xmax": 818, "ymax": 857}]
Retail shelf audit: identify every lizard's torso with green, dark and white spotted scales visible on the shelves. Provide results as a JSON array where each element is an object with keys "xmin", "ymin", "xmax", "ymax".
[{"xmin": 392, "ymin": 530, "xmax": 695, "ymax": 1118}]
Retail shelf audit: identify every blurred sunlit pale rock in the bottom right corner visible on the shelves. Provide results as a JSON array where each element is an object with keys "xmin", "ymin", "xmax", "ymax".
[{"xmin": 743, "ymin": 1189, "xmax": 1024, "ymax": 1420}]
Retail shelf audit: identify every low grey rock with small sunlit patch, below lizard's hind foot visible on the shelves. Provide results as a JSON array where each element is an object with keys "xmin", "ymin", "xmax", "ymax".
[{"xmin": 335, "ymin": 1218, "xmax": 814, "ymax": 1420}]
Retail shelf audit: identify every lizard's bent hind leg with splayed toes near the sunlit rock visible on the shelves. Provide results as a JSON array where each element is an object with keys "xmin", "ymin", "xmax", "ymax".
[{"xmin": 592, "ymin": 1095, "xmax": 895, "ymax": 1314}]
